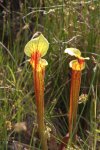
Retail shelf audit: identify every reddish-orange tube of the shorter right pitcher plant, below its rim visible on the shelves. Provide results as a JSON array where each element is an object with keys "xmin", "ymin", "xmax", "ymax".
[{"xmin": 69, "ymin": 69, "xmax": 81, "ymax": 139}]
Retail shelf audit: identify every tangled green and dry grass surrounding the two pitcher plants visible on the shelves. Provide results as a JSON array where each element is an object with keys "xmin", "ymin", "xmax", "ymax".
[{"xmin": 0, "ymin": 0, "xmax": 100, "ymax": 150}]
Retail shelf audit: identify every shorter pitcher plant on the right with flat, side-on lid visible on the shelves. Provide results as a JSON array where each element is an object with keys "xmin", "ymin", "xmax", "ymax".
[{"xmin": 65, "ymin": 48, "xmax": 89, "ymax": 140}]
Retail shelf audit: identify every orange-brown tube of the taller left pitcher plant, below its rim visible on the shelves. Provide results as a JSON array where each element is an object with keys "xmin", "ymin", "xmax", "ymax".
[{"xmin": 33, "ymin": 68, "xmax": 48, "ymax": 150}]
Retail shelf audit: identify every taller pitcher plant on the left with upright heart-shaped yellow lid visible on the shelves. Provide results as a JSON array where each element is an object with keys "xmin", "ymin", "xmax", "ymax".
[{"xmin": 24, "ymin": 33, "xmax": 49, "ymax": 150}]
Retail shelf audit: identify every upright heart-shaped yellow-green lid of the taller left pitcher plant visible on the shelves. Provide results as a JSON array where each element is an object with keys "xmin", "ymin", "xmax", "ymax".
[{"xmin": 24, "ymin": 34, "xmax": 49, "ymax": 57}]
